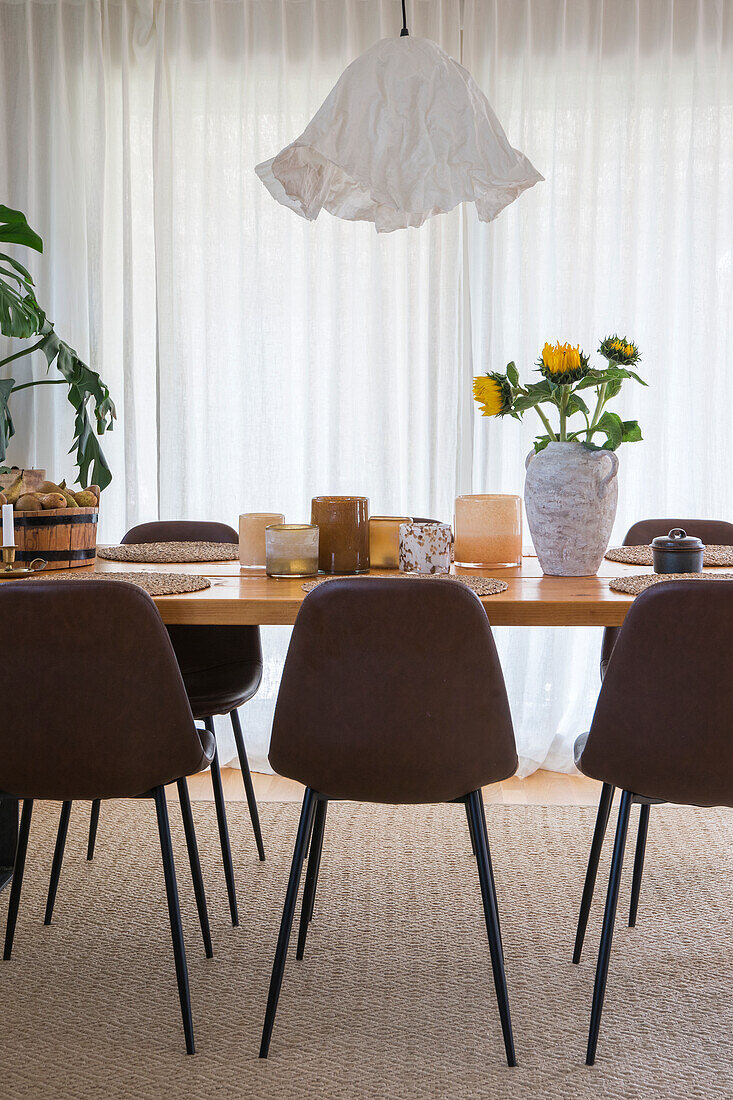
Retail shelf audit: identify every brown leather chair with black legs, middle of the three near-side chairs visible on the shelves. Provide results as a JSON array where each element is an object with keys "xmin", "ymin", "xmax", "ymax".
[{"xmin": 260, "ymin": 578, "xmax": 517, "ymax": 1066}]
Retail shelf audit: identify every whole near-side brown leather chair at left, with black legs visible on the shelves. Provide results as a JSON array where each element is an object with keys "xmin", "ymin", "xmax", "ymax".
[{"xmin": 0, "ymin": 580, "xmax": 215, "ymax": 1054}]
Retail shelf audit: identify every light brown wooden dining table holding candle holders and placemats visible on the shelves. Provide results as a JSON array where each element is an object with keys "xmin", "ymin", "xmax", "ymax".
[{"xmin": 0, "ymin": 554, "xmax": 649, "ymax": 890}]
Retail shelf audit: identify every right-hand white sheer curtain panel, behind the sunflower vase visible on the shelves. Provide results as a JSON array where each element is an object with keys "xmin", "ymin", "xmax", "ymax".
[{"xmin": 463, "ymin": 0, "xmax": 733, "ymax": 771}]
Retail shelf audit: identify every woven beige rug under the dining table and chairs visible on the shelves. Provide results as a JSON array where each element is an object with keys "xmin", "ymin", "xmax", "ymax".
[{"xmin": 0, "ymin": 802, "xmax": 733, "ymax": 1100}]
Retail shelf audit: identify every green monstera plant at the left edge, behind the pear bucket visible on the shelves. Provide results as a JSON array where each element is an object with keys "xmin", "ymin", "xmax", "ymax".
[{"xmin": 0, "ymin": 205, "xmax": 117, "ymax": 488}]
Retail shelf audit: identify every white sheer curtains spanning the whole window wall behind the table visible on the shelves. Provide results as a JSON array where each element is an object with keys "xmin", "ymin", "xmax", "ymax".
[{"xmin": 0, "ymin": 0, "xmax": 733, "ymax": 772}]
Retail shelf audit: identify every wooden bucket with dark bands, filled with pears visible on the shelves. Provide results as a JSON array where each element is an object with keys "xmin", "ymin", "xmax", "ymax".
[{"xmin": 0, "ymin": 471, "xmax": 100, "ymax": 570}]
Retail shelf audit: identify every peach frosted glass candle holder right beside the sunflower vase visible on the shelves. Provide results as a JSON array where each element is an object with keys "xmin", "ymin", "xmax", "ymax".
[{"xmin": 456, "ymin": 493, "xmax": 522, "ymax": 569}]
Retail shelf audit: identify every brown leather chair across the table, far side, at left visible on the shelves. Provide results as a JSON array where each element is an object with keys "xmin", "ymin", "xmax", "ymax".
[{"xmin": 56, "ymin": 519, "xmax": 265, "ymax": 926}]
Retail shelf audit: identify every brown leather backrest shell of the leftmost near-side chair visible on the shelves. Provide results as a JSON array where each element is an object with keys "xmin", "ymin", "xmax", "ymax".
[{"xmin": 0, "ymin": 580, "xmax": 208, "ymax": 800}]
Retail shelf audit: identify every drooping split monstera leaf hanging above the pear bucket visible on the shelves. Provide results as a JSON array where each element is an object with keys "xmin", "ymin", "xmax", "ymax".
[{"xmin": 41, "ymin": 322, "xmax": 117, "ymax": 488}]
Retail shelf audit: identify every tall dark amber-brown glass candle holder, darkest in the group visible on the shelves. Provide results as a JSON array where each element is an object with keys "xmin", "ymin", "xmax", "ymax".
[{"xmin": 310, "ymin": 496, "xmax": 369, "ymax": 573}]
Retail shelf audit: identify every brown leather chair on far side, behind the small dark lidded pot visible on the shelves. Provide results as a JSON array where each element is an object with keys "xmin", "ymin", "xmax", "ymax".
[{"xmin": 572, "ymin": 519, "xmax": 733, "ymax": 963}]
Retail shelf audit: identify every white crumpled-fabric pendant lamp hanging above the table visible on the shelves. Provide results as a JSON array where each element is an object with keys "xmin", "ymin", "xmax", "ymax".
[{"xmin": 255, "ymin": 0, "xmax": 544, "ymax": 233}]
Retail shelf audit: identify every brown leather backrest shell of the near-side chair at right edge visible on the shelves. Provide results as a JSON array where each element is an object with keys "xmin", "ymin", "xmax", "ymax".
[{"xmin": 580, "ymin": 580, "xmax": 733, "ymax": 806}]
